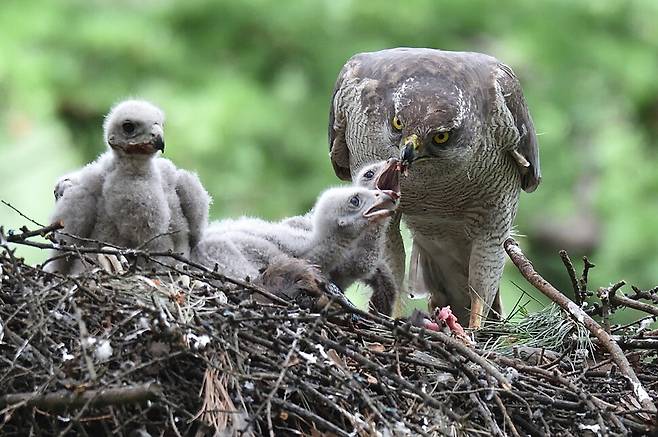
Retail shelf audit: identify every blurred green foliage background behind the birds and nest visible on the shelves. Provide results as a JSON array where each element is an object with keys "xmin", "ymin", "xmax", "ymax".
[{"xmin": 0, "ymin": 0, "xmax": 658, "ymax": 314}]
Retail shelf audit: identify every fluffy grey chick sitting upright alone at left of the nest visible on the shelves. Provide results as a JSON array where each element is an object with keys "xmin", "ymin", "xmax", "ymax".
[{"xmin": 48, "ymin": 100, "xmax": 210, "ymax": 273}]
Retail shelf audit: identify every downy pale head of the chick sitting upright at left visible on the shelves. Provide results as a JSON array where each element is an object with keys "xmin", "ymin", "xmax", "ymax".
[{"xmin": 103, "ymin": 100, "xmax": 165, "ymax": 155}]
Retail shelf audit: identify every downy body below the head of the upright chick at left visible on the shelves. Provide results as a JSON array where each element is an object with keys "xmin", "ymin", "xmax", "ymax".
[{"xmin": 52, "ymin": 151, "xmax": 210, "ymax": 270}]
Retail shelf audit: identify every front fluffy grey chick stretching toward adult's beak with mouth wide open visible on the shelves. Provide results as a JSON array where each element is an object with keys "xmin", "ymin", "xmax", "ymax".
[{"xmin": 192, "ymin": 187, "xmax": 397, "ymax": 288}]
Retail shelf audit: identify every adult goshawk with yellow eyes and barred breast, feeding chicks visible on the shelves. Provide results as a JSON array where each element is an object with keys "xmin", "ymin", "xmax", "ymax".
[{"xmin": 329, "ymin": 48, "xmax": 540, "ymax": 327}]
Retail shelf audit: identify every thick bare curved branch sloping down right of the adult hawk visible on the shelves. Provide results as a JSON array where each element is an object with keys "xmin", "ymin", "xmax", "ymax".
[{"xmin": 504, "ymin": 238, "xmax": 656, "ymax": 414}]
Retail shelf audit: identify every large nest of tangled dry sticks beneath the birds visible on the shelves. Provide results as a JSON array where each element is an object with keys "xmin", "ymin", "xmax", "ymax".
[{"xmin": 0, "ymin": 228, "xmax": 658, "ymax": 436}]
